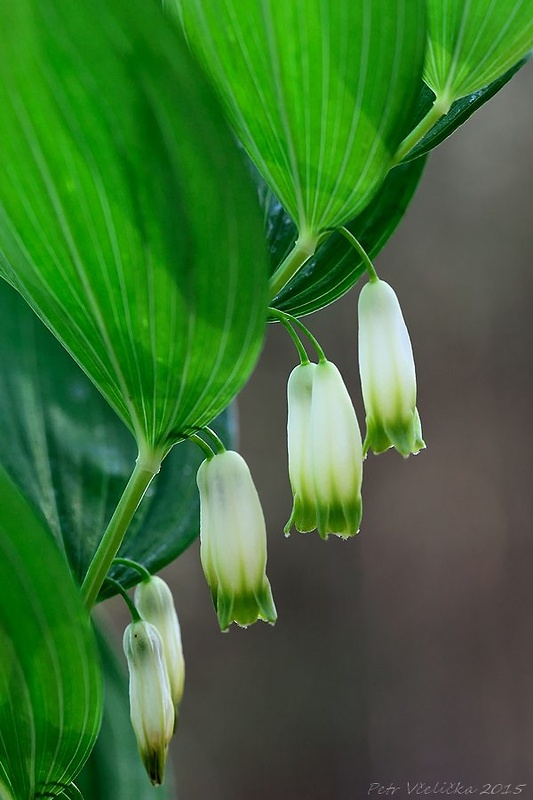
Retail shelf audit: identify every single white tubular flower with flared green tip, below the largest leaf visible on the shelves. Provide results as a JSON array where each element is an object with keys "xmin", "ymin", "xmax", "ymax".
[{"xmin": 197, "ymin": 450, "xmax": 276, "ymax": 631}]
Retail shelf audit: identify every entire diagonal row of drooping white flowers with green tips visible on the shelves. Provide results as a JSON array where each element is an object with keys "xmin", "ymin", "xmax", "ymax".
[{"xmin": 124, "ymin": 275, "xmax": 424, "ymax": 784}]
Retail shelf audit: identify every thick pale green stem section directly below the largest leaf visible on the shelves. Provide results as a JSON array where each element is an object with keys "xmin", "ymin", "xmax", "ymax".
[{"xmin": 81, "ymin": 459, "xmax": 157, "ymax": 610}]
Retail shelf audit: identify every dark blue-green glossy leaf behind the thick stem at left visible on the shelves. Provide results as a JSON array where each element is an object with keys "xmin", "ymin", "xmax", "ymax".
[{"xmin": 0, "ymin": 281, "xmax": 232, "ymax": 594}]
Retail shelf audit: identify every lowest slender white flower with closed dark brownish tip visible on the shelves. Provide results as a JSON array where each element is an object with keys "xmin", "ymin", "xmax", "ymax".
[{"xmin": 123, "ymin": 620, "xmax": 174, "ymax": 785}]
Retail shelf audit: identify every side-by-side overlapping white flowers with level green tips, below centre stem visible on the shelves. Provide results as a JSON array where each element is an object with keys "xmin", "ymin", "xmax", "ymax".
[{"xmin": 285, "ymin": 361, "xmax": 363, "ymax": 539}]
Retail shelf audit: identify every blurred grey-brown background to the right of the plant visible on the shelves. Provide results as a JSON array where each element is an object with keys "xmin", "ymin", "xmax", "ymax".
[{"xmin": 108, "ymin": 65, "xmax": 533, "ymax": 800}]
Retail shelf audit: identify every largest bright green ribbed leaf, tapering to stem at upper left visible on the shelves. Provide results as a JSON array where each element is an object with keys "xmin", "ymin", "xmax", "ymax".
[{"xmin": 0, "ymin": 0, "xmax": 266, "ymax": 457}]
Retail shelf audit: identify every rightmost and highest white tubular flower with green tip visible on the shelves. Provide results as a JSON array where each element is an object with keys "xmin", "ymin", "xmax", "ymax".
[{"xmin": 359, "ymin": 280, "xmax": 425, "ymax": 457}]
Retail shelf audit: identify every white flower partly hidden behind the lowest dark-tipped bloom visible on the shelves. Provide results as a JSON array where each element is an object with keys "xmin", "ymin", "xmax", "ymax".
[{"xmin": 134, "ymin": 575, "xmax": 185, "ymax": 707}]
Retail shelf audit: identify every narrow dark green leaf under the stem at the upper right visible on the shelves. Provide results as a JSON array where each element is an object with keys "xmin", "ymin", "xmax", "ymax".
[{"xmin": 404, "ymin": 55, "xmax": 530, "ymax": 162}]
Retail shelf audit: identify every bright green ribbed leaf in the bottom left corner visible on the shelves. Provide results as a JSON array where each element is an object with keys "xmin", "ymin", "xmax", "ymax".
[{"xmin": 0, "ymin": 470, "xmax": 102, "ymax": 800}]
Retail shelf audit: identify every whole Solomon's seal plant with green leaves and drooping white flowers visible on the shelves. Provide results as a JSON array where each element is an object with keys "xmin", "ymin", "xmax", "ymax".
[{"xmin": 0, "ymin": 0, "xmax": 533, "ymax": 800}]
